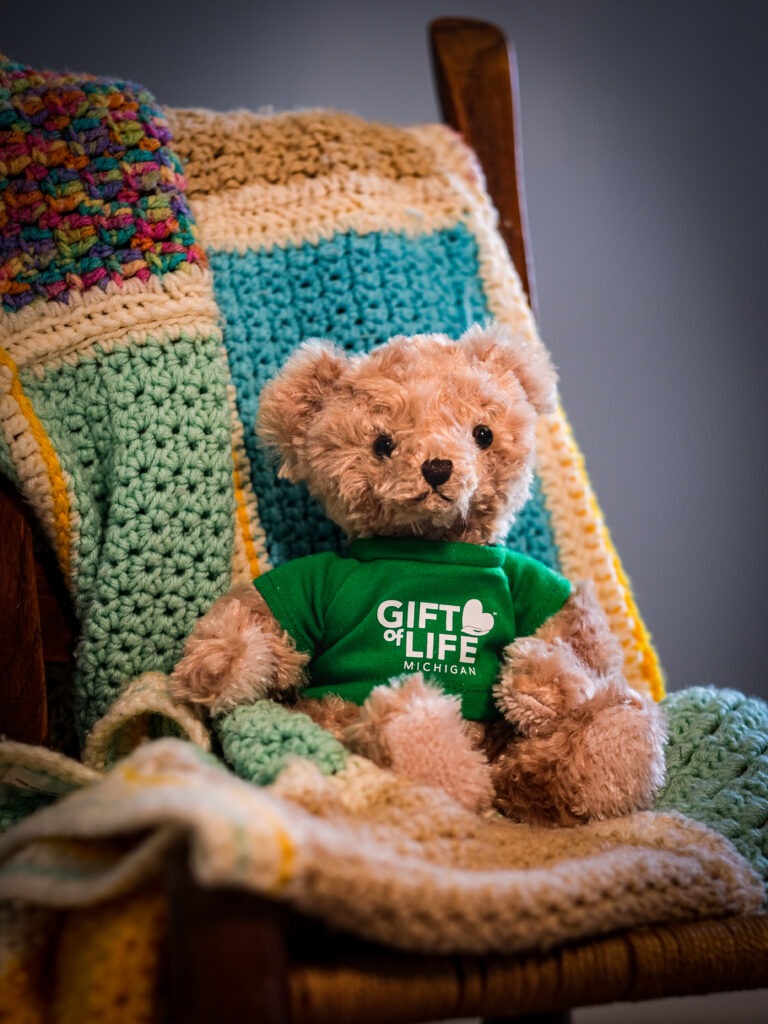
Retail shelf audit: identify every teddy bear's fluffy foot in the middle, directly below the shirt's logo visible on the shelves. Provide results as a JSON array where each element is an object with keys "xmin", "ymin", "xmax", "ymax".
[{"xmin": 345, "ymin": 672, "xmax": 493, "ymax": 811}]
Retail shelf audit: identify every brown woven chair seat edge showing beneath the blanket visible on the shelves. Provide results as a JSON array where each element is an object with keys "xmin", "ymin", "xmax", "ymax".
[{"xmin": 290, "ymin": 914, "xmax": 768, "ymax": 1024}]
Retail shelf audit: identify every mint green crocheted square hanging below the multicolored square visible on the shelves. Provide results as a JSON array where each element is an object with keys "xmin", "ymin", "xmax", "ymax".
[{"xmin": 19, "ymin": 334, "xmax": 234, "ymax": 734}]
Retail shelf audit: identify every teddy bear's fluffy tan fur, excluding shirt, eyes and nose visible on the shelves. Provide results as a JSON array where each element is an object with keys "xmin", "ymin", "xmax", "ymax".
[{"xmin": 169, "ymin": 325, "xmax": 665, "ymax": 824}]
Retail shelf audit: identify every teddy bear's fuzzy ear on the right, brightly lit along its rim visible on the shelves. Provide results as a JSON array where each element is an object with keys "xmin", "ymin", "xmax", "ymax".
[{"xmin": 459, "ymin": 322, "xmax": 557, "ymax": 413}]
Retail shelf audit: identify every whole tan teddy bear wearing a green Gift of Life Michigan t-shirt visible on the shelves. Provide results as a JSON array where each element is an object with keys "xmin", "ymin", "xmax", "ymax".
[{"xmin": 172, "ymin": 323, "xmax": 666, "ymax": 825}]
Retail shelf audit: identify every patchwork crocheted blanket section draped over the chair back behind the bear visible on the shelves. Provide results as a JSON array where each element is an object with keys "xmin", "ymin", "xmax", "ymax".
[{"xmin": 0, "ymin": 61, "xmax": 663, "ymax": 738}]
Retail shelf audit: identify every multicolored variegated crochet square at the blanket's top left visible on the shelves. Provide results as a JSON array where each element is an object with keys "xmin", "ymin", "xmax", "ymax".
[{"xmin": 0, "ymin": 59, "xmax": 203, "ymax": 310}]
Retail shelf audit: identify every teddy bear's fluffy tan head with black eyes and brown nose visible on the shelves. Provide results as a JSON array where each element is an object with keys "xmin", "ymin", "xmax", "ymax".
[{"xmin": 258, "ymin": 324, "xmax": 557, "ymax": 544}]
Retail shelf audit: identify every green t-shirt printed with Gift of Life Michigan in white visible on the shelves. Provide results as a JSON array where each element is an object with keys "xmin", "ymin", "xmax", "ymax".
[{"xmin": 254, "ymin": 538, "xmax": 570, "ymax": 721}]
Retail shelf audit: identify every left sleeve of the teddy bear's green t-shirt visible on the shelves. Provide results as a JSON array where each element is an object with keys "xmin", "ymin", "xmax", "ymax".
[{"xmin": 253, "ymin": 552, "xmax": 354, "ymax": 654}]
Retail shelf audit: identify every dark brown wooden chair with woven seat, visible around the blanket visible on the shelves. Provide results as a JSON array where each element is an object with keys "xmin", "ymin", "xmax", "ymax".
[{"xmin": 0, "ymin": 18, "xmax": 768, "ymax": 1024}]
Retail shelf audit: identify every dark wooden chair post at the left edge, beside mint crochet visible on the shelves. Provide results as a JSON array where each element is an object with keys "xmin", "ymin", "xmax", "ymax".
[{"xmin": 0, "ymin": 478, "xmax": 48, "ymax": 743}]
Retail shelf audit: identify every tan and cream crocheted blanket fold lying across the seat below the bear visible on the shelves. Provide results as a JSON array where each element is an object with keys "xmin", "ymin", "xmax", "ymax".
[{"xmin": 0, "ymin": 739, "xmax": 764, "ymax": 953}]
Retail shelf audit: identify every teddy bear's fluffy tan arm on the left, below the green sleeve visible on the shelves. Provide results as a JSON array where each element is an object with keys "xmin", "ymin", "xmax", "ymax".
[{"xmin": 171, "ymin": 584, "xmax": 307, "ymax": 715}]
